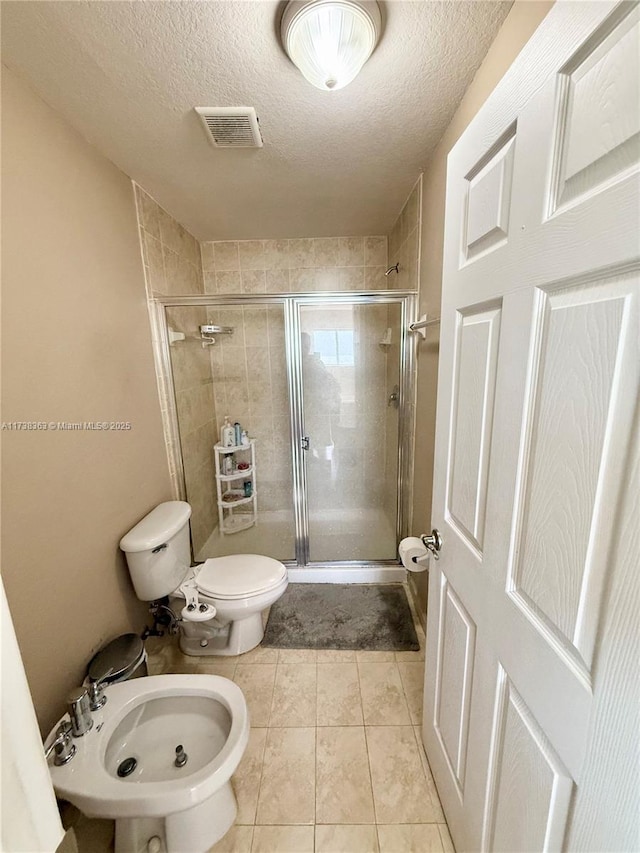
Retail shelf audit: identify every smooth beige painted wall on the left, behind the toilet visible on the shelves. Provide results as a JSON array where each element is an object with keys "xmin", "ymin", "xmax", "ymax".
[{"xmin": 2, "ymin": 69, "xmax": 171, "ymax": 731}]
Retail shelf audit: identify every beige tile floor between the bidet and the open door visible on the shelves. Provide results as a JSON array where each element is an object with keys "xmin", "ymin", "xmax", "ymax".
[{"xmin": 143, "ymin": 600, "xmax": 453, "ymax": 853}]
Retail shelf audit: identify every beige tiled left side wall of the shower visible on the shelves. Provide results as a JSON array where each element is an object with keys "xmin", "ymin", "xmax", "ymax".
[{"xmin": 135, "ymin": 186, "xmax": 218, "ymax": 552}]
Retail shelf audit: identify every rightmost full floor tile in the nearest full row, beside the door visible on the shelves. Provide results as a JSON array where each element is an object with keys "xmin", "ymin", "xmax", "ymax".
[{"xmin": 364, "ymin": 726, "xmax": 441, "ymax": 824}]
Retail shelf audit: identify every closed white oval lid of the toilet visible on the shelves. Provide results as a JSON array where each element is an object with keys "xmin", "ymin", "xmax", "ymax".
[{"xmin": 196, "ymin": 554, "xmax": 287, "ymax": 598}]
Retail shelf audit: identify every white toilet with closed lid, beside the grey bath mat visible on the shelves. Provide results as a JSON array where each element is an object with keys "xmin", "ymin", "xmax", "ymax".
[{"xmin": 120, "ymin": 501, "xmax": 288, "ymax": 655}]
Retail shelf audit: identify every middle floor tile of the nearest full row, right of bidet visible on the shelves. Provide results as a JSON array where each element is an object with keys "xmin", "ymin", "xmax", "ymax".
[{"xmin": 316, "ymin": 726, "xmax": 375, "ymax": 824}]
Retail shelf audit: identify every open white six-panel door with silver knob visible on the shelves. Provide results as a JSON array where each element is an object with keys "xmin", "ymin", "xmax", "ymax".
[{"xmin": 423, "ymin": 0, "xmax": 640, "ymax": 853}]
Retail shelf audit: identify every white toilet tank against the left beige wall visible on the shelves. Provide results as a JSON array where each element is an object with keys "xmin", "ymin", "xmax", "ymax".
[{"xmin": 120, "ymin": 501, "xmax": 191, "ymax": 601}]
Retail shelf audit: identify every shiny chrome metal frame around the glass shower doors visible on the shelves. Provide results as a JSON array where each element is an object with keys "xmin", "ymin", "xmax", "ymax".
[{"xmin": 150, "ymin": 290, "xmax": 418, "ymax": 582}]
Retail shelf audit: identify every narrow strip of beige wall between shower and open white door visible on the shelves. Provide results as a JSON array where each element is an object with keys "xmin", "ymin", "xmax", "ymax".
[{"xmin": 412, "ymin": 0, "xmax": 553, "ymax": 624}]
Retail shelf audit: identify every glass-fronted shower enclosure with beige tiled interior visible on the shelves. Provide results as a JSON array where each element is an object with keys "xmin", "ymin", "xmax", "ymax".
[{"xmin": 157, "ymin": 291, "xmax": 415, "ymax": 568}]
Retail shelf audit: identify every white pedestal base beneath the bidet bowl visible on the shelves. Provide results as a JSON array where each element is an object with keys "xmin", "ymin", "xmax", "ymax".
[{"xmin": 115, "ymin": 782, "xmax": 238, "ymax": 853}]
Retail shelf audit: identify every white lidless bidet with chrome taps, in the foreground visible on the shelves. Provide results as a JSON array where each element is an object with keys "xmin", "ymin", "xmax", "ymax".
[{"xmin": 45, "ymin": 675, "xmax": 249, "ymax": 853}]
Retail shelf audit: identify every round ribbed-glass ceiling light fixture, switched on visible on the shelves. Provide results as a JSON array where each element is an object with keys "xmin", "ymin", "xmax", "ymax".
[{"xmin": 281, "ymin": 0, "xmax": 382, "ymax": 92}]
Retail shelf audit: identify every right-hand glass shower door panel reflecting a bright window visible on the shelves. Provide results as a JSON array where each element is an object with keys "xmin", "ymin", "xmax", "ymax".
[{"xmin": 299, "ymin": 302, "xmax": 401, "ymax": 563}]
